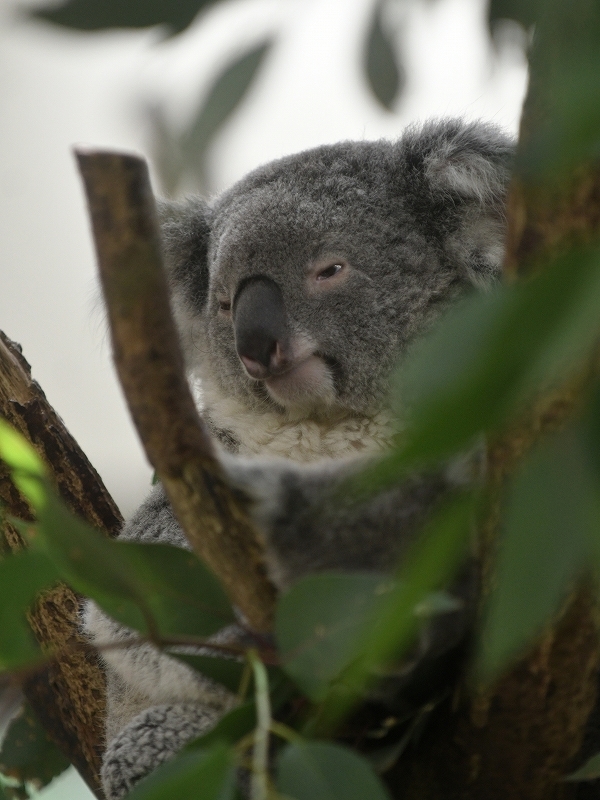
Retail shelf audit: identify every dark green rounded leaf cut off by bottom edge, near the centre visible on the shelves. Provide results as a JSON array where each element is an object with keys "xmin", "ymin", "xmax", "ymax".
[{"xmin": 277, "ymin": 742, "xmax": 389, "ymax": 800}]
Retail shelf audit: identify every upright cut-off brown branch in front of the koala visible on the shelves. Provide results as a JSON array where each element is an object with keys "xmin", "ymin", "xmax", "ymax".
[{"xmin": 78, "ymin": 152, "xmax": 275, "ymax": 631}]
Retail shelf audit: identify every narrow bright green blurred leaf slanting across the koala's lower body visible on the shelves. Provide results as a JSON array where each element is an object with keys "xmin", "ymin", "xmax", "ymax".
[{"xmin": 309, "ymin": 495, "xmax": 475, "ymax": 735}]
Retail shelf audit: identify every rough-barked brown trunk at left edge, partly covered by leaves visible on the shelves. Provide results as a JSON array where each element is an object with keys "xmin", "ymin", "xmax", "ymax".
[{"xmin": 0, "ymin": 331, "xmax": 122, "ymax": 797}]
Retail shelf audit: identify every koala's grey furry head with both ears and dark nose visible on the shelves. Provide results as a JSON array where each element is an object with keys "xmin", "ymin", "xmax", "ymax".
[{"xmin": 161, "ymin": 121, "xmax": 512, "ymax": 417}]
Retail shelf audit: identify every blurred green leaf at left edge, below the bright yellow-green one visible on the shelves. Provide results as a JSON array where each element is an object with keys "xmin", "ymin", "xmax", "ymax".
[{"xmin": 0, "ymin": 552, "xmax": 60, "ymax": 669}]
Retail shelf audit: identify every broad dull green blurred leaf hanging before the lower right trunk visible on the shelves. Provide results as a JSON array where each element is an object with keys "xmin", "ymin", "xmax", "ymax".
[{"xmin": 477, "ymin": 428, "xmax": 600, "ymax": 679}]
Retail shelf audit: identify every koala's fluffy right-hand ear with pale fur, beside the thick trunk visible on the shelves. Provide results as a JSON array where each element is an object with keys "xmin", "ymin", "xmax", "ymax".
[{"xmin": 402, "ymin": 120, "xmax": 514, "ymax": 288}]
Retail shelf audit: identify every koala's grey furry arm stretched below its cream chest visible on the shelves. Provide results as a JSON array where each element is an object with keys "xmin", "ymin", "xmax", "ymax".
[{"xmin": 222, "ymin": 455, "xmax": 456, "ymax": 590}]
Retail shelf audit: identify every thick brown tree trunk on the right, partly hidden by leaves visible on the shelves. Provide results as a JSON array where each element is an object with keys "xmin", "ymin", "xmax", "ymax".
[{"xmin": 389, "ymin": 15, "xmax": 600, "ymax": 800}]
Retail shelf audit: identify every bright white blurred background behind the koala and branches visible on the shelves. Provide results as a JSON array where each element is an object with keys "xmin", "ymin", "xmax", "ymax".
[{"xmin": 0, "ymin": 0, "xmax": 527, "ymax": 800}]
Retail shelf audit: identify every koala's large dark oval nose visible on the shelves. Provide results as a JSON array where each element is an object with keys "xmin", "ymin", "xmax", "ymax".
[{"xmin": 233, "ymin": 277, "xmax": 289, "ymax": 380}]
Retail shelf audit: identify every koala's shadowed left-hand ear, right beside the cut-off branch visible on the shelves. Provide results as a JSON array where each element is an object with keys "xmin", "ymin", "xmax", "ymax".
[{"xmin": 157, "ymin": 197, "xmax": 210, "ymax": 314}]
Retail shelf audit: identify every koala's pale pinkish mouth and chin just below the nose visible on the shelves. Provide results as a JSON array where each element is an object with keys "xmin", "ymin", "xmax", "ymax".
[{"xmin": 264, "ymin": 353, "xmax": 336, "ymax": 409}]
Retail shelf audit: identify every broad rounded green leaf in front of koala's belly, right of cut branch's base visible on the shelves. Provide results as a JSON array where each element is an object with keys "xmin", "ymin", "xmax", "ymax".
[{"xmin": 275, "ymin": 572, "xmax": 394, "ymax": 701}]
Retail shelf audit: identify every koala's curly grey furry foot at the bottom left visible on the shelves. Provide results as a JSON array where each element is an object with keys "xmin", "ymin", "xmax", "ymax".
[{"xmin": 100, "ymin": 703, "xmax": 219, "ymax": 800}]
